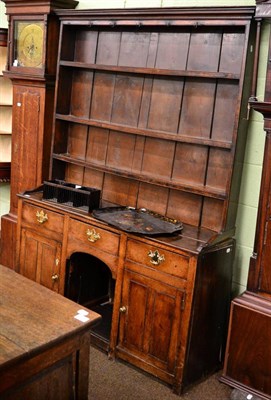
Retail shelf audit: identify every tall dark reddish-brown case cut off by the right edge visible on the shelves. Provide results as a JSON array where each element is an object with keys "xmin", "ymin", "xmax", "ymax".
[{"xmin": 221, "ymin": 0, "xmax": 271, "ymax": 399}]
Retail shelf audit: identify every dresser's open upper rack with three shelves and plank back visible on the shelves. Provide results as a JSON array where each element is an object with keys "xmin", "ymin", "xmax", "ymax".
[{"xmin": 50, "ymin": 12, "xmax": 255, "ymax": 231}]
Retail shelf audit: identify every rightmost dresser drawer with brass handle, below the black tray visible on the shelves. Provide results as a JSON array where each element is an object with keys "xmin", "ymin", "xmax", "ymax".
[{"xmin": 126, "ymin": 240, "xmax": 189, "ymax": 278}]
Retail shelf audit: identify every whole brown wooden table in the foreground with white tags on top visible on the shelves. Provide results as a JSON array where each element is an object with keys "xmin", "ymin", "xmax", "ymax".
[{"xmin": 0, "ymin": 265, "xmax": 100, "ymax": 400}]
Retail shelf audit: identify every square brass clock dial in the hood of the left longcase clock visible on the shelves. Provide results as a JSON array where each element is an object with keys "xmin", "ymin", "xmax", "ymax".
[{"xmin": 13, "ymin": 21, "xmax": 44, "ymax": 68}]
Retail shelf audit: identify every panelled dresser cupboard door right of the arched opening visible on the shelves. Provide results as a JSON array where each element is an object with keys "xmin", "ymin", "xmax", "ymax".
[{"xmin": 118, "ymin": 270, "xmax": 184, "ymax": 374}]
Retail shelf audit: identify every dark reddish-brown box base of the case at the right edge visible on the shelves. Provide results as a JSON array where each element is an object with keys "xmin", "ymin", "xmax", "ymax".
[{"xmin": 221, "ymin": 292, "xmax": 271, "ymax": 399}]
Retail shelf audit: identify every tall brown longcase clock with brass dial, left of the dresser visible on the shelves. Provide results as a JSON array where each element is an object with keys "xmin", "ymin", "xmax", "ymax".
[{"xmin": 0, "ymin": 0, "xmax": 78, "ymax": 268}]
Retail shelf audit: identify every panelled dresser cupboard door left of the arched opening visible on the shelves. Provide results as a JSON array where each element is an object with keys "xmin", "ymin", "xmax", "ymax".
[{"xmin": 20, "ymin": 229, "xmax": 61, "ymax": 292}]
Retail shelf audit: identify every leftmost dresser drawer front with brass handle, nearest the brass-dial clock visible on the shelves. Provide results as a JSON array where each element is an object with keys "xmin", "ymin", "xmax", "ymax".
[{"xmin": 22, "ymin": 203, "xmax": 64, "ymax": 234}]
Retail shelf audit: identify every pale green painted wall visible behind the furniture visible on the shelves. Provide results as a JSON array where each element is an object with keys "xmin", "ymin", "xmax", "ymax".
[{"xmin": 0, "ymin": 0, "xmax": 269, "ymax": 295}]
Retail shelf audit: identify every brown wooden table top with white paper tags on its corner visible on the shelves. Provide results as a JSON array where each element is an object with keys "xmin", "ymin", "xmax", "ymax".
[{"xmin": 0, "ymin": 265, "xmax": 100, "ymax": 371}]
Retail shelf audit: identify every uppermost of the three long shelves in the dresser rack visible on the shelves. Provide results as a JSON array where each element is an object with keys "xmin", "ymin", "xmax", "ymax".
[{"xmin": 59, "ymin": 60, "xmax": 240, "ymax": 80}]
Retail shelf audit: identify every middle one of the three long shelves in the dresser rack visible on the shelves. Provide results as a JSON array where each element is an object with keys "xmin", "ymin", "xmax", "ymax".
[{"xmin": 55, "ymin": 114, "xmax": 232, "ymax": 150}]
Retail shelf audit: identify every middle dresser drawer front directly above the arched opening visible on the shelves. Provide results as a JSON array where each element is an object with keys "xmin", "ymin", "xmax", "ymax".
[{"xmin": 68, "ymin": 219, "xmax": 120, "ymax": 255}]
